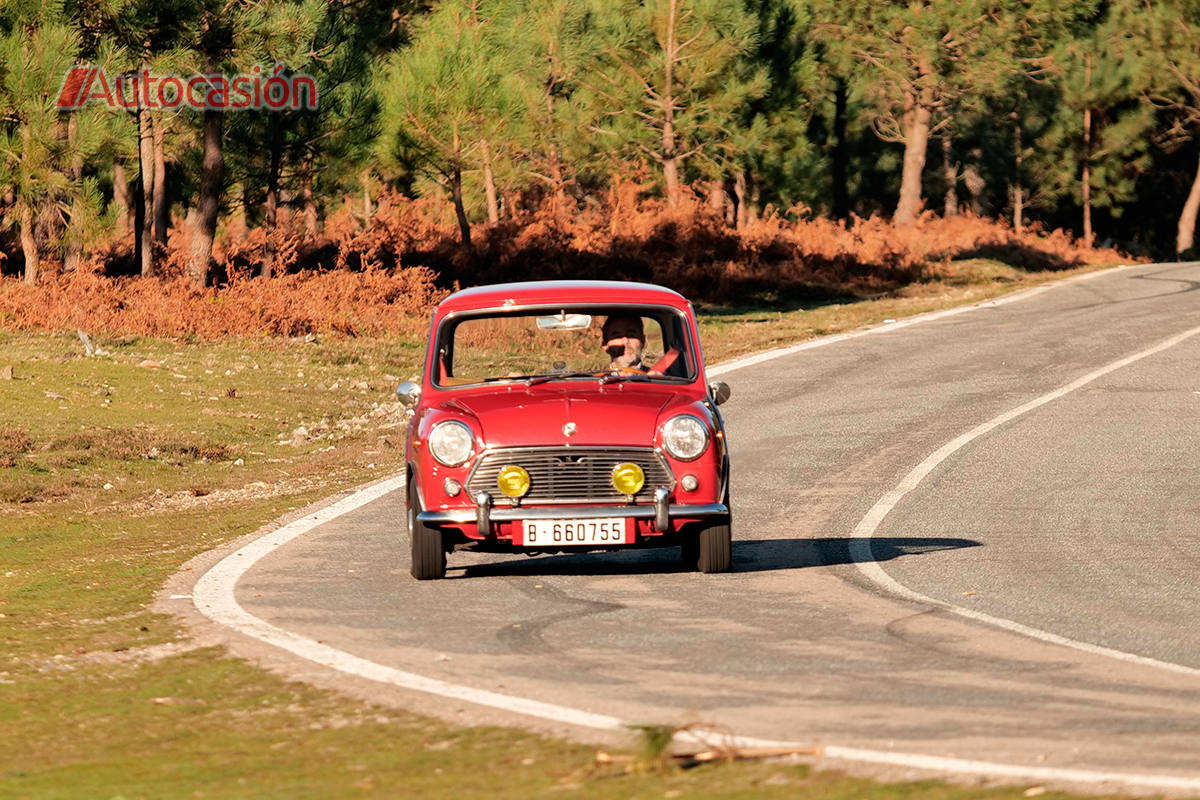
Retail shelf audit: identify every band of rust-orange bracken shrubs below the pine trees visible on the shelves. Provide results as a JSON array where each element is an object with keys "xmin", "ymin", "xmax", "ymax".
[{"xmin": 0, "ymin": 191, "xmax": 1118, "ymax": 339}]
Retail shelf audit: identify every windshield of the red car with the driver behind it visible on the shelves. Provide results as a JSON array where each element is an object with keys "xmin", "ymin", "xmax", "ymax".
[{"xmin": 433, "ymin": 306, "xmax": 696, "ymax": 386}]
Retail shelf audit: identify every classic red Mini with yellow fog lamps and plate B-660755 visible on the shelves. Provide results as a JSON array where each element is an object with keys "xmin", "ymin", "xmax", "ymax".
[{"xmin": 396, "ymin": 281, "xmax": 732, "ymax": 581}]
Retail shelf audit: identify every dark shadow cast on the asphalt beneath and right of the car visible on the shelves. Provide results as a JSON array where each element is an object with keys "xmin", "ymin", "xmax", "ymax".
[{"xmin": 448, "ymin": 536, "xmax": 983, "ymax": 578}]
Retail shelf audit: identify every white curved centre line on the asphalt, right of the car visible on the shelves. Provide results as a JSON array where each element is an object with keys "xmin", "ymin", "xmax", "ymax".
[{"xmin": 850, "ymin": 327, "xmax": 1200, "ymax": 675}]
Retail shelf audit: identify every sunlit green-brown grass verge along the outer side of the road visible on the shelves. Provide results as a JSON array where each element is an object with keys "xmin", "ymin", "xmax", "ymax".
[{"xmin": 0, "ymin": 263, "xmax": 1132, "ymax": 800}]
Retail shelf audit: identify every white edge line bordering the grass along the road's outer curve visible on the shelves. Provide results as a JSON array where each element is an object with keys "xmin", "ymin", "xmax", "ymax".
[{"xmin": 192, "ymin": 267, "xmax": 1200, "ymax": 793}]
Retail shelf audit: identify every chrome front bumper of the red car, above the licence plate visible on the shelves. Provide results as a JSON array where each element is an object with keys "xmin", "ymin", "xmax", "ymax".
[{"xmin": 416, "ymin": 488, "xmax": 730, "ymax": 536}]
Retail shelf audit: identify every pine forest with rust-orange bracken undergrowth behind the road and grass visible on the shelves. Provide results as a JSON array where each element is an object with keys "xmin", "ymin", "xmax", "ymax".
[{"xmin": 0, "ymin": 0, "xmax": 1200, "ymax": 335}]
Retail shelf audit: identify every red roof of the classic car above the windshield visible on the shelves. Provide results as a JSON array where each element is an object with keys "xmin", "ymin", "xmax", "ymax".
[{"xmin": 437, "ymin": 281, "xmax": 689, "ymax": 317}]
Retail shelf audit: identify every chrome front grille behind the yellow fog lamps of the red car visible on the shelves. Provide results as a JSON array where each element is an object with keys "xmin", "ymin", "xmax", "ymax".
[{"xmin": 467, "ymin": 446, "xmax": 674, "ymax": 504}]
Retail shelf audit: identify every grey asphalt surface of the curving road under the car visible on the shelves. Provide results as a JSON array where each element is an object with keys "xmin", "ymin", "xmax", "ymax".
[{"xmin": 225, "ymin": 264, "xmax": 1200, "ymax": 777}]
